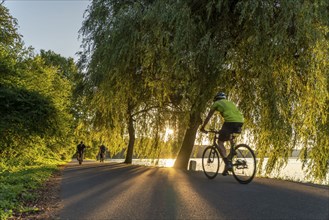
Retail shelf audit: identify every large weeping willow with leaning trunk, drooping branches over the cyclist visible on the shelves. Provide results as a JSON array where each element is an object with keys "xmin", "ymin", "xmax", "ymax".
[{"xmin": 81, "ymin": 0, "xmax": 329, "ymax": 182}]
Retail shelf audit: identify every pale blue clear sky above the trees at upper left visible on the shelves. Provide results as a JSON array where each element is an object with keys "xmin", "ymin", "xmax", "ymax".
[{"xmin": 4, "ymin": 0, "xmax": 90, "ymax": 60}]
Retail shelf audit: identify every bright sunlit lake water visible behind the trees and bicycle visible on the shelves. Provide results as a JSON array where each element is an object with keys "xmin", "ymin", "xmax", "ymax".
[{"xmin": 107, "ymin": 158, "xmax": 329, "ymax": 185}]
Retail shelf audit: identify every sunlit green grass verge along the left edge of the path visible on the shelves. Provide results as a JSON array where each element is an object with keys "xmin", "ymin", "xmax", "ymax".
[{"xmin": 0, "ymin": 159, "xmax": 65, "ymax": 220}]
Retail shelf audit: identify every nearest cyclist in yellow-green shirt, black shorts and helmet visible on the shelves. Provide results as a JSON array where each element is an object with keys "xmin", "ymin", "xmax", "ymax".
[{"xmin": 200, "ymin": 92, "xmax": 244, "ymax": 176}]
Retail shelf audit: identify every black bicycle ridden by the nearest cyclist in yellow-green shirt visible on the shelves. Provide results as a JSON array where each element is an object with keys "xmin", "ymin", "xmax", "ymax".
[{"xmin": 202, "ymin": 130, "xmax": 256, "ymax": 184}]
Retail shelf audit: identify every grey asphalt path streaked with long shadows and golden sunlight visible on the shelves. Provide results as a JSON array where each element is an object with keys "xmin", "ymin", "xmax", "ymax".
[{"xmin": 60, "ymin": 162, "xmax": 329, "ymax": 220}]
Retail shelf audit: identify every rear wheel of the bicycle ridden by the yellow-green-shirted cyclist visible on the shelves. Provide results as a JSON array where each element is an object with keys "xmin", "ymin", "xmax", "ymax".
[{"xmin": 232, "ymin": 144, "xmax": 256, "ymax": 184}]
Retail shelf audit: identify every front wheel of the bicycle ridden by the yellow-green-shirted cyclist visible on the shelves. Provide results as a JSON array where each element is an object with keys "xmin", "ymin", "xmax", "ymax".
[{"xmin": 202, "ymin": 146, "xmax": 219, "ymax": 179}]
